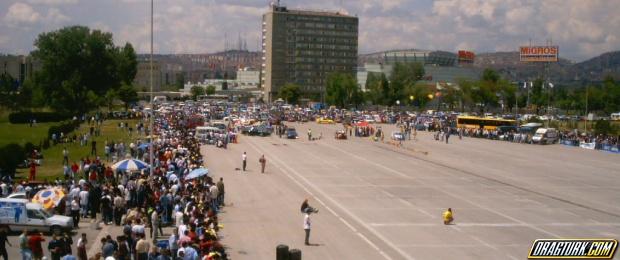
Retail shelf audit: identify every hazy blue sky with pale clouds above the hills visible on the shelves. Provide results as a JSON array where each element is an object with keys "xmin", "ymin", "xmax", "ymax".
[{"xmin": 0, "ymin": 0, "xmax": 620, "ymax": 61}]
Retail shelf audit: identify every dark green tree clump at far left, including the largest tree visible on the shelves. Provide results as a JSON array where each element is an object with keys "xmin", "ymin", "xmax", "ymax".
[{"xmin": 0, "ymin": 26, "xmax": 138, "ymax": 113}]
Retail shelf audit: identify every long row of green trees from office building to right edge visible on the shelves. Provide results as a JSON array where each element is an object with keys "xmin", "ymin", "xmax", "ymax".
[{"xmin": 290, "ymin": 63, "xmax": 620, "ymax": 114}]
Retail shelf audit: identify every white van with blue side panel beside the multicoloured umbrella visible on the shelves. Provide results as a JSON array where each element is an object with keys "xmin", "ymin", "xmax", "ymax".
[{"xmin": 0, "ymin": 198, "xmax": 73, "ymax": 234}]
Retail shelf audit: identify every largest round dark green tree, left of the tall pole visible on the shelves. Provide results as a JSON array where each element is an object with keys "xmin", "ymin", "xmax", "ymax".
[{"xmin": 32, "ymin": 26, "xmax": 135, "ymax": 113}]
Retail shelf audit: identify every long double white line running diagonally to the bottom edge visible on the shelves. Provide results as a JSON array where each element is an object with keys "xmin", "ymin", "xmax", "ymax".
[{"xmin": 246, "ymin": 138, "xmax": 398, "ymax": 260}]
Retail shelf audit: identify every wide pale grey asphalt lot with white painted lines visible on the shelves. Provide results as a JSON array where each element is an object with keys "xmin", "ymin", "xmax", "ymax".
[{"xmin": 203, "ymin": 123, "xmax": 620, "ymax": 259}]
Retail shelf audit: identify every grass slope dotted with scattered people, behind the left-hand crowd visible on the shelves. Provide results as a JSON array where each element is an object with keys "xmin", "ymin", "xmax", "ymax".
[{"xmin": 14, "ymin": 120, "xmax": 147, "ymax": 180}]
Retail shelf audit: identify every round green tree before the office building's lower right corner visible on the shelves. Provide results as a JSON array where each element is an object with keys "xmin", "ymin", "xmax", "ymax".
[{"xmin": 325, "ymin": 73, "xmax": 363, "ymax": 108}]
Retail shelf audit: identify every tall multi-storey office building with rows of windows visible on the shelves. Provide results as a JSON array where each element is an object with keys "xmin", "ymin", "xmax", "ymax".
[{"xmin": 261, "ymin": 5, "xmax": 358, "ymax": 101}]
